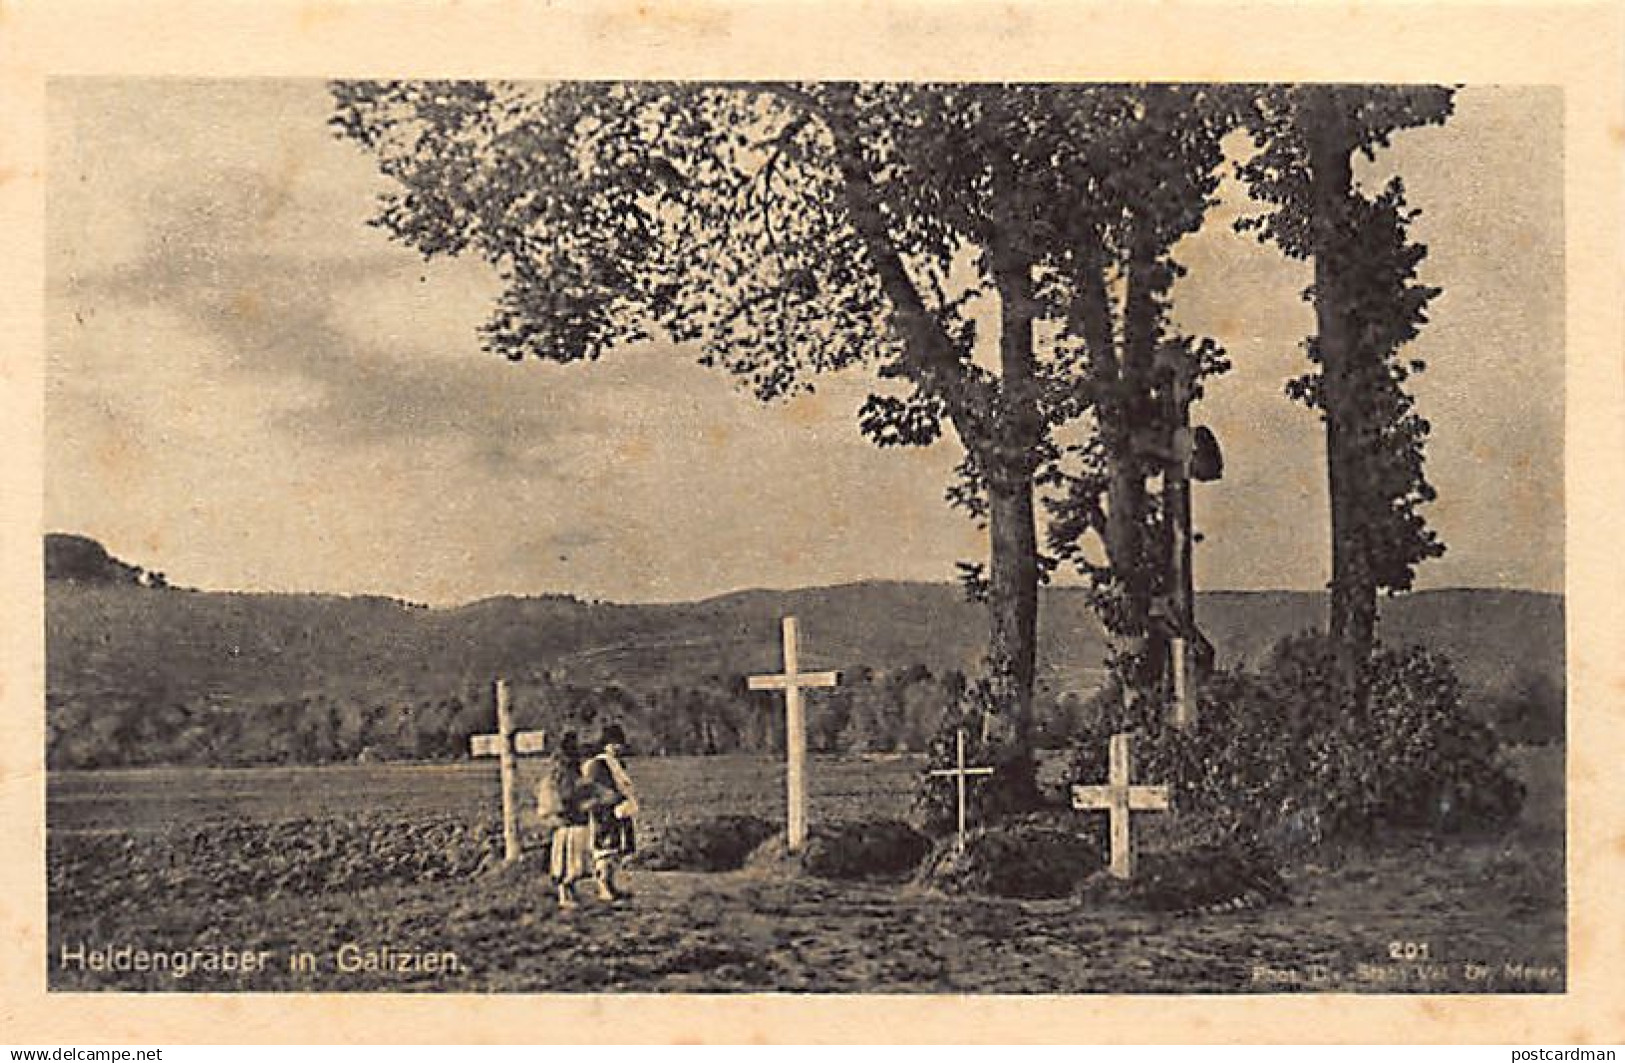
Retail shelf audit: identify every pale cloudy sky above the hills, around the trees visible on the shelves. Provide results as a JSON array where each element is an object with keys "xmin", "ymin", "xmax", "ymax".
[{"xmin": 46, "ymin": 80, "xmax": 1563, "ymax": 605}]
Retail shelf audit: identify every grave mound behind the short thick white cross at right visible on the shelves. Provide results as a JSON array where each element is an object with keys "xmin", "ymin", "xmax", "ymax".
[{"xmin": 1077, "ymin": 844, "xmax": 1290, "ymax": 912}]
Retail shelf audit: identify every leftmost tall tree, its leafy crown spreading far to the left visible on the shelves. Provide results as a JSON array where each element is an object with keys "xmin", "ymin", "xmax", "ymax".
[{"xmin": 323, "ymin": 83, "xmax": 1150, "ymax": 799}]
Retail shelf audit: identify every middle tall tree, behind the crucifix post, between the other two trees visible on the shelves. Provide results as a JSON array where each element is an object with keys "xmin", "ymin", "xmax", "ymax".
[{"xmin": 1050, "ymin": 85, "xmax": 1245, "ymax": 711}]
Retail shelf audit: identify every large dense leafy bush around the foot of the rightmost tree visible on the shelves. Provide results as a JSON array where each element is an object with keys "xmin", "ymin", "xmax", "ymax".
[{"xmin": 1069, "ymin": 636, "xmax": 1523, "ymax": 848}]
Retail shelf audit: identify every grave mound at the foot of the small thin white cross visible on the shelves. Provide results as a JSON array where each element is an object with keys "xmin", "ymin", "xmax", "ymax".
[{"xmin": 915, "ymin": 824, "xmax": 1103, "ymax": 900}]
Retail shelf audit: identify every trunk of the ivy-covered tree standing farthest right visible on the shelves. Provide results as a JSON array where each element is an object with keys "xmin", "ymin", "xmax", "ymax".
[{"xmin": 1303, "ymin": 89, "xmax": 1376, "ymax": 701}]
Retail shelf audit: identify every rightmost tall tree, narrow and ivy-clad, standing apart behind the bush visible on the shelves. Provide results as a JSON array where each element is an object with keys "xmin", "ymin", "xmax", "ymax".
[{"xmin": 1240, "ymin": 85, "xmax": 1453, "ymax": 692}]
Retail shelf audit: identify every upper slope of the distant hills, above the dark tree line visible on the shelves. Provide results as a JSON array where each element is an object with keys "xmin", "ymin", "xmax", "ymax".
[{"xmin": 46, "ymin": 559, "xmax": 1563, "ymax": 715}]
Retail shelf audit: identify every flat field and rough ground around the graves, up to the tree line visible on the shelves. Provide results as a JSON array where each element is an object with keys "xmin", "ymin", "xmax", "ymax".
[{"xmin": 47, "ymin": 748, "xmax": 1565, "ymax": 993}]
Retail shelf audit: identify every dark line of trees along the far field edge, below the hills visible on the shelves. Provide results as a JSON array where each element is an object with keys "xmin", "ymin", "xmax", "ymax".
[{"xmin": 46, "ymin": 665, "xmax": 1089, "ymax": 769}]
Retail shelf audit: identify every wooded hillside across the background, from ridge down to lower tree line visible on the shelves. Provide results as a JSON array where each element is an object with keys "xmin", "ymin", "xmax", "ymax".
[{"xmin": 46, "ymin": 536, "xmax": 1563, "ymax": 767}]
